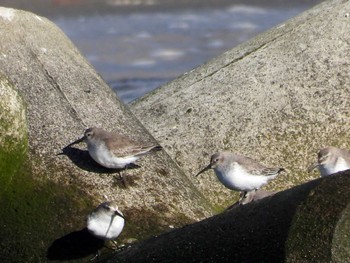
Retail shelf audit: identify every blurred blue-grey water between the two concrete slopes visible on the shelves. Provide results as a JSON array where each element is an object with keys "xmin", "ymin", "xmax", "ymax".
[{"xmin": 0, "ymin": 0, "xmax": 321, "ymax": 103}]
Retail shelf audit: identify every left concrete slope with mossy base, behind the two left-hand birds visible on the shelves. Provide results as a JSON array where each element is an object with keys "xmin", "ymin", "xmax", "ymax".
[{"xmin": 0, "ymin": 8, "xmax": 212, "ymax": 262}]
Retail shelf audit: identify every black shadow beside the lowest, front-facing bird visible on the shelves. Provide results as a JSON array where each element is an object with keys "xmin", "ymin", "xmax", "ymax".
[{"xmin": 46, "ymin": 228, "xmax": 104, "ymax": 260}]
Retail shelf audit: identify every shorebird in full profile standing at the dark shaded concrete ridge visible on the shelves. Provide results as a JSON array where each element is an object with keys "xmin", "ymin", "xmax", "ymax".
[{"xmin": 196, "ymin": 152, "xmax": 284, "ymax": 201}]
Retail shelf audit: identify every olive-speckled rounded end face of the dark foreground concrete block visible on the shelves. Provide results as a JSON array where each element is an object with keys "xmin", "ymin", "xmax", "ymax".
[{"xmin": 286, "ymin": 171, "xmax": 350, "ymax": 262}]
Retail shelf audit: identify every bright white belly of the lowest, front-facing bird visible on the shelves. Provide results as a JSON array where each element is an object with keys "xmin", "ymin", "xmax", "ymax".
[{"xmin": 87, "ymin": 216, "xmax": 124, "ymax": 239}]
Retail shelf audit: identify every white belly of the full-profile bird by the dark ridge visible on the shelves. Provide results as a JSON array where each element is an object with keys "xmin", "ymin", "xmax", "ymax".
[{"xmin": 215, "ymin": 168, "xmax": 268, "ymax": 191}]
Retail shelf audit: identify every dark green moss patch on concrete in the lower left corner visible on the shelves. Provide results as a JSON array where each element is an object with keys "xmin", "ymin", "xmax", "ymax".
[{"xmin": 0, "ymin": 157, "xmax": 92, "ymax": 262}]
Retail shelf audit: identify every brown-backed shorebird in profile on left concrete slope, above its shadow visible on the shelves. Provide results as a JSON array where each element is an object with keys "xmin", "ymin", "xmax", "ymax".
[{"xmin": 66, "ymin": 127, "xmax": 162, "ymax": 169}]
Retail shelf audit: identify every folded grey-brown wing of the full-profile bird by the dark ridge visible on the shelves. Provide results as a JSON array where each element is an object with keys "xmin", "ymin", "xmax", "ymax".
[{"xmin": 236, "ymin": 155, "xmax": 284, "ymax": 176}]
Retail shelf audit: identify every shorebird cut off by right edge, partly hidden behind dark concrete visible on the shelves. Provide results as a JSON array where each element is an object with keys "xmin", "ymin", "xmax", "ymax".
[{"xmin": 308, "ymin": 147, "xmax": 350, "ymax": 176}]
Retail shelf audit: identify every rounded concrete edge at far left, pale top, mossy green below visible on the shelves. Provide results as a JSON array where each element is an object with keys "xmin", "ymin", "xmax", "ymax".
[{"xmin": 0, "ymin": 73, "xmax": 28, "ymax": 260}]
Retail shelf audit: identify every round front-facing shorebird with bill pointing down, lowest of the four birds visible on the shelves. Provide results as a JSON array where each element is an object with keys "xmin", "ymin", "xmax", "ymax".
[{"xmin": 87, "ymin": 201, "xmax": 125, "ymax": 243}]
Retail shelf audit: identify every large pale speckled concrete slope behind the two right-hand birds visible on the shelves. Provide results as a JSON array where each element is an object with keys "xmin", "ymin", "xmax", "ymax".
[{"xmin": 131, "ymin": 0, "xmax": 350, "ymax": 206}]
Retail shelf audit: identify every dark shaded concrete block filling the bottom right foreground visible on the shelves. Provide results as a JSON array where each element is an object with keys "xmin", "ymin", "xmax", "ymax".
[{"xmin": 104, "ymin": 171, "xmax": 350, "ymax": 263}]
